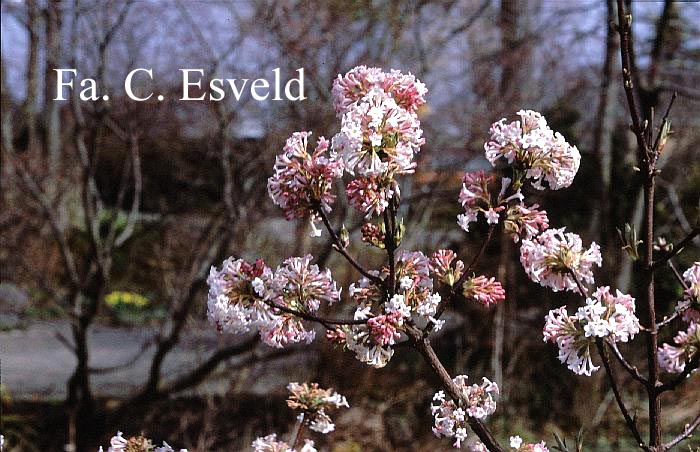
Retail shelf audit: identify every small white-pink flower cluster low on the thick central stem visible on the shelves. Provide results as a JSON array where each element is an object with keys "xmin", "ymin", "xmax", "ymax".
[{"xmin": 430, "ymin": 375, "xmax": 499, "ymax": 449}]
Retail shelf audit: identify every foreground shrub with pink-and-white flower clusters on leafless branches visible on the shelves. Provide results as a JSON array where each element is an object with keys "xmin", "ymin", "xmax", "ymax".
[{"xmin": 200, "ymin": 66, "xmax": 700, "ymax": 452}]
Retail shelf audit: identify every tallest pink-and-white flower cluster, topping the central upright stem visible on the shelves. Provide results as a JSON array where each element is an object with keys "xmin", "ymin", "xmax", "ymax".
[{"xmin": 332, "ymin": 66, "xmax": 427, "ymax": 218}]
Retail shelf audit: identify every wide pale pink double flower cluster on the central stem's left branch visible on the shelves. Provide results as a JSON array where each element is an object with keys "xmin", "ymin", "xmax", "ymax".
[{"xmin": 207, "ymin": 255, "xmax": 340, "ymax": 348}]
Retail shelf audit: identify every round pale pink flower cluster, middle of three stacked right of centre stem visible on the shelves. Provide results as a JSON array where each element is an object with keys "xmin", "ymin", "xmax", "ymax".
[{"xmin": 520, "ymin": 228, "xmax": 602, "ymax": 292}]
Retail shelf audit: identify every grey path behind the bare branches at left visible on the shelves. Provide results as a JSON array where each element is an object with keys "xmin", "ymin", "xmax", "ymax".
[{"xmin": 0, "ymin": 321, "xmax": 303, "ymax": 399}]
